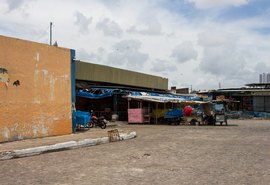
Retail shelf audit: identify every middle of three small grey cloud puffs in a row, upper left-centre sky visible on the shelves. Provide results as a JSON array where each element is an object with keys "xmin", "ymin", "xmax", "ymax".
[{"xmin": 97, "ymin": 18, "xmax": 123, "ymax": 37}]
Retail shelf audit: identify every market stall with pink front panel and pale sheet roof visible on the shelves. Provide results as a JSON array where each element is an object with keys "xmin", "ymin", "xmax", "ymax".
[{"xmin": 125, "ymin": 92, "xmax": 199, "ymax": 124}]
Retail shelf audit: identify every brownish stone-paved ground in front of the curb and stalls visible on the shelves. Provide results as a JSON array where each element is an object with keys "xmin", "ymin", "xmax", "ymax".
[{"xmin": 0, "ymin": 120, "xmax": 270, "ymax": 185}]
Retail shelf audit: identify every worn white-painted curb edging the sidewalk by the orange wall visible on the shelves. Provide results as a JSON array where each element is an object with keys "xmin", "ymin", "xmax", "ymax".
[{"xmin": 0, "ymin": 131, "xmax": 137, "ymax": 161}]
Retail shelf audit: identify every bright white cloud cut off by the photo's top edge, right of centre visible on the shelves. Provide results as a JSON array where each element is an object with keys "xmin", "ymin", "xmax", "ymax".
[{"xmin": 186, "ymin": 0, "xmax": 249, "ymax": 9}]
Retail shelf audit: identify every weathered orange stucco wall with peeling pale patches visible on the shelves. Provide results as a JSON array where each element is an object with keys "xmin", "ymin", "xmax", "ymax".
[{"xmin": 0, "ymin": 35, "xmax": 72, "ymax": 142}]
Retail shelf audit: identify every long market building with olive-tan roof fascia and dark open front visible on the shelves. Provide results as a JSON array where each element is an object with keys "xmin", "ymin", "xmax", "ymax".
[{"xmin": 76, "ymin": 61, "xmax": 168, "ymax": 121}]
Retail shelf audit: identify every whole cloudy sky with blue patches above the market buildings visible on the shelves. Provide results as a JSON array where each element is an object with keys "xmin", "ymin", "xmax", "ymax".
[{"xmin": 0, "ymin": 0, "xmax": 270, "ymax": 90}]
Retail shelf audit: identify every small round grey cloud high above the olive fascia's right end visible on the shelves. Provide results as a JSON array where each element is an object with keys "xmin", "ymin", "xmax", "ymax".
[{"xmin": 171, "ymin": 41, "xmax": 198, "ymax": 63}]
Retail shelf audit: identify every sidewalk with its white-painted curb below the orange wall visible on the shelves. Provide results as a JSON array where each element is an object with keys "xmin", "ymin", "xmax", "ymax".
[{"xmin": 0, "ymin": 122, "xmax": 136, "ymax": 160}]
